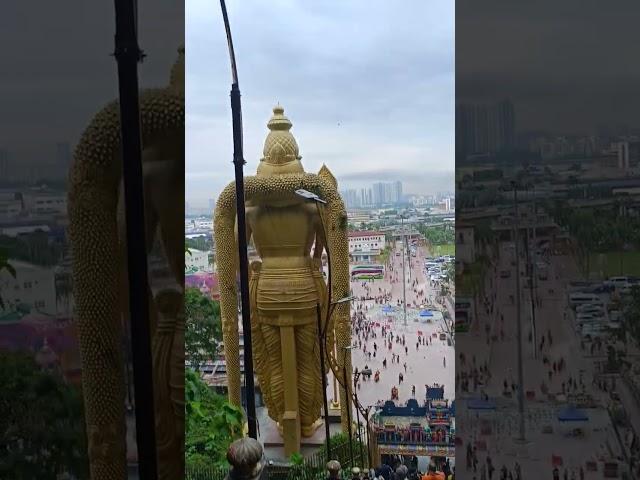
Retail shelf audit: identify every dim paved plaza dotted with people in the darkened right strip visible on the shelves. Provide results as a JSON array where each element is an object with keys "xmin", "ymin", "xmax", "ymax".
[{"xmin": 457, "ymin": 240, "xmax": 619, "ymax": 479}]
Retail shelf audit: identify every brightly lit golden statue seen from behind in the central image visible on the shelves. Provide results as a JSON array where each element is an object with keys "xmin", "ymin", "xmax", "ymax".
[{"xmin": 214, "ymin": 106, "xmax": 351, "ymax": 456}]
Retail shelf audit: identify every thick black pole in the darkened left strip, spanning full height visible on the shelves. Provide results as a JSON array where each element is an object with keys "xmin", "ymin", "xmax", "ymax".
[{"xmin": 114, "ymin": 0, "xmax": 158, "ymax": 480}]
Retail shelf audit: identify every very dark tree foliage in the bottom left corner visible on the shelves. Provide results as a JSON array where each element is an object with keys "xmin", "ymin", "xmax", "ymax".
[{"xmin": 0, "ymin": 352, "xmax": 89, "ymax": 480}]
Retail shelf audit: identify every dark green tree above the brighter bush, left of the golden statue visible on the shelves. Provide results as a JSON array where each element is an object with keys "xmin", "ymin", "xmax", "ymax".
[{"xmin": 184, "ymin": 288, "xmax": 222, "ymax": 370}]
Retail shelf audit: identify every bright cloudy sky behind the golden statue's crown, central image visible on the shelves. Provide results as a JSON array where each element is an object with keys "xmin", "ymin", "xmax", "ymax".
[{"xmin": 185, "ymin": 0, "xmax": 455, "ymax": 205}]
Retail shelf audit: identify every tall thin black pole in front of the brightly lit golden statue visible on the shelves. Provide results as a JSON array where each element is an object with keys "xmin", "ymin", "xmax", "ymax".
[{"xmin": 220, "ymin": 0, "xmax": 258, "ymax": 439}]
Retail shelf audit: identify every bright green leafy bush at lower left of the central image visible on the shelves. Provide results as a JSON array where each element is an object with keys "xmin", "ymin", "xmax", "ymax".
[{"xmin": 185, "ymin": 369, "xmax": 244, "ymax": 469}]
